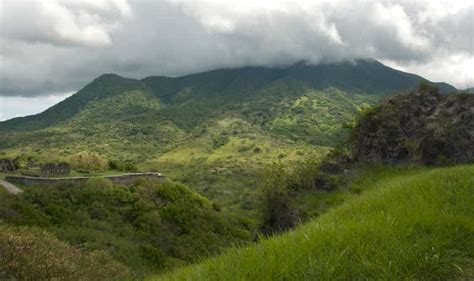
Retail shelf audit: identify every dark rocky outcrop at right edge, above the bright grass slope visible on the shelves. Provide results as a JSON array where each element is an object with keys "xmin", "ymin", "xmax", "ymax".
[{"xmin": 351, "ymin": 91, "xmax": 474, "ymax": 165}]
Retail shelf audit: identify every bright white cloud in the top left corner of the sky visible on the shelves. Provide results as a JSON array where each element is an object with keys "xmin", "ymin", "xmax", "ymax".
[{"xmin": 0, "ymin": 0, "xmax": 132, "ymax": 47}]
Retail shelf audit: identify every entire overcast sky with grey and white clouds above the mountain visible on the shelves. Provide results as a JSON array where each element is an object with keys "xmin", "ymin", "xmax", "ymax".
[{"xmin": 0, "ymin": 0, "xmax": 474, "ymax": 120}]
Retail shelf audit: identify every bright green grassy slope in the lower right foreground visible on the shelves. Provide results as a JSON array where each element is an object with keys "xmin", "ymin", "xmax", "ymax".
[{"xmin": 151, "ymin": 165, "xmax": 474, "ymax": 280}]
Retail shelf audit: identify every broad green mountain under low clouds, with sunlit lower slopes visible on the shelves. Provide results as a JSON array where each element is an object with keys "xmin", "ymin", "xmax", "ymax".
[{"xmin": 0, "ymin": 60, "xmax": 456, "ymax": 215}]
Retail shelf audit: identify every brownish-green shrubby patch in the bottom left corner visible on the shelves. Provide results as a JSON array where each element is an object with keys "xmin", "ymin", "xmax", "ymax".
[{"xmin": 0, "ymin": 226, "xmax": 128, "ymax": 280}]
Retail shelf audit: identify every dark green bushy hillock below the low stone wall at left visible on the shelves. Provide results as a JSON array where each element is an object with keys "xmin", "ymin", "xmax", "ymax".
[{"xmin": 0, "ymin": 178, "xmax": 249, "ymax": 279}]
